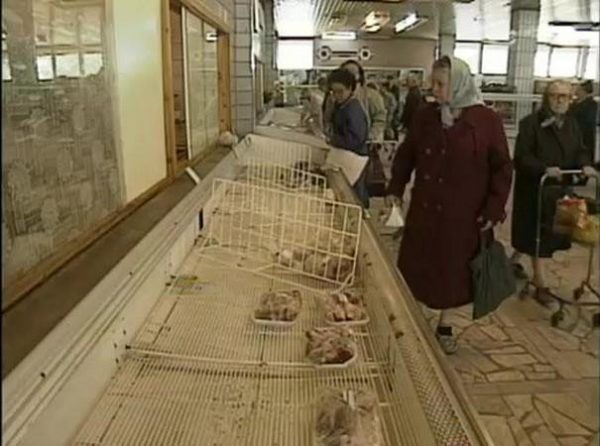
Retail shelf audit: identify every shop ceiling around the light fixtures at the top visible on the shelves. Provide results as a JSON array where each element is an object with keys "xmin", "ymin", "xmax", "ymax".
[{"xmin": 274, "ymin": 0, "xmax": 600, "ymax": 47}]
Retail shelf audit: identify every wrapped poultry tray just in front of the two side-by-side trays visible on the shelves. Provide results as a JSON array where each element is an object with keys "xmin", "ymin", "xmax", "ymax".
[{"xmin": 306, "ymin": 327, "xmax": 356, "ymax": 365}]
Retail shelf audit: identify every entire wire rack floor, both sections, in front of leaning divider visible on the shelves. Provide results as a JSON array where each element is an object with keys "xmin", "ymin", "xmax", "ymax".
[{"xmin": 74, "ymin": 251, "xmax": 434, "ymax": 446}]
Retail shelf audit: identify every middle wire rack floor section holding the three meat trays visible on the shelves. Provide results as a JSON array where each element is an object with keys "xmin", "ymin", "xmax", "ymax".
[{"xmin": 132, "ymin": 258, "xmax": 398, "ymax": 367}]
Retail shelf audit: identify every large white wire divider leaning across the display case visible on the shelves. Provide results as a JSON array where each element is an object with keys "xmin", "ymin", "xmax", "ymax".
[{"xmin": 203, "ymin": 180, "xmax": 362, "ymax": 288}]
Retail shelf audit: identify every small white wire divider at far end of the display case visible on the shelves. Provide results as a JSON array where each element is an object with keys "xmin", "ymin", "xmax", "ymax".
[{"xmin": 234, "ymin": 134, "xmax": 312, "ymax": 166}]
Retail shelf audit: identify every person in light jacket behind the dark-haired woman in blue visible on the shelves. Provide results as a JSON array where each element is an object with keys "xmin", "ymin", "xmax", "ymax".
[{"xmin": 323, "ymin": 60, "xmax": 386, "ymax": 141}]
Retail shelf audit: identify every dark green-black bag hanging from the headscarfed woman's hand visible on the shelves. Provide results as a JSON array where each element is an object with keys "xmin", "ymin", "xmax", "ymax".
[{"xmin": 470, "ymin": 230, "xmax": 517, "ymax": 319}]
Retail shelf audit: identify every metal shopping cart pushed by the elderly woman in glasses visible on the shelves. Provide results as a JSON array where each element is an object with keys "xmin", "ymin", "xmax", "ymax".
[{"xmin": 520, "ymin": 169, "xmax": 600, "ymax": 327}]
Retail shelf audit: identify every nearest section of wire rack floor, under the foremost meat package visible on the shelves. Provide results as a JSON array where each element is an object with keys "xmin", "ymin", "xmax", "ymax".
[{"xmin": 74, "ymin": 353, "xmax": 432, "ymax": 446}]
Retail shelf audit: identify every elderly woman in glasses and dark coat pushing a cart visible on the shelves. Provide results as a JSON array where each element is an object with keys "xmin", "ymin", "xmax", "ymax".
[{"xmin": 512, "ymin": 81, "xmax": 594, "ymax": 304}]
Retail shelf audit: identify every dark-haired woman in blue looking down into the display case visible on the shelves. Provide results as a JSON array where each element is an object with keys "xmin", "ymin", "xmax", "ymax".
[{"xmin": 329, "ymin": 69, "xmax": 369, "ymax": 208}]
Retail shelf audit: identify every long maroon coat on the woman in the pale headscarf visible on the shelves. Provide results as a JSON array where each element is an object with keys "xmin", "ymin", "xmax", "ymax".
[{"xmin": 388, "ymin": 105, "xmax": 512, "ymax": 309}]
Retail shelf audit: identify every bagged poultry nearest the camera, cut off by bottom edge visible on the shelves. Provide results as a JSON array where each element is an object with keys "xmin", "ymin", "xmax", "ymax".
[{"xmin": 316, "ymin": 389, "xmax": 383, "ymax": 446}]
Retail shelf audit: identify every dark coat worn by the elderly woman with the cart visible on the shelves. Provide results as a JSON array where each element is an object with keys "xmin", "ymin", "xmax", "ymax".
[{"xmin": 512, "ymin": 111, "xmax": 590, "ymax": 258}]
